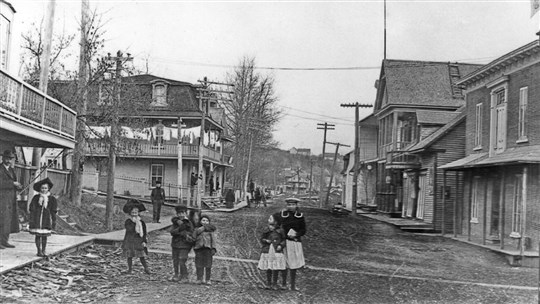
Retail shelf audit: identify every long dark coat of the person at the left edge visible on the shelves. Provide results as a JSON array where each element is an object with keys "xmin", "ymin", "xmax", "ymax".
[{"xmin": 0, "ymin": 164, "xmax": 19, "ymax": 235}]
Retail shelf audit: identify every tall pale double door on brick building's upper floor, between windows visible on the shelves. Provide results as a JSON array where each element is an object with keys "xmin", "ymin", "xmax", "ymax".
[{"xmin": 489, "ymin": 84, "xmax": 508, "ymax": 155}]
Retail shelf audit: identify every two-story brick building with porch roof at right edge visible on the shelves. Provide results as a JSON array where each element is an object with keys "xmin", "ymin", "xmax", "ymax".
[{"xmin": 441, "ymin": 41, "xmax": 540, "ymax": 257}]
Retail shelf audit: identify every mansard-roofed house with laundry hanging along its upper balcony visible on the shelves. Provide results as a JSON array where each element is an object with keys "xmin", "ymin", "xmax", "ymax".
[{"xmin": 75, "ymin": 74, "xmax": 231, "ymax": 203}]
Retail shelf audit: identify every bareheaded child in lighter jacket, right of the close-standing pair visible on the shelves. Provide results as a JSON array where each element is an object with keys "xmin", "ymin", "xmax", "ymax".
[{"xmin": 193, "ymin": 215, "xmax": 216, "ymax": 285}]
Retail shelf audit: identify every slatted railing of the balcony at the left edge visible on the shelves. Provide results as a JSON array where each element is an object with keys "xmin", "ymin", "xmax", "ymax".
[{"xmin": 0, "ymin": 69, "xmax": 76, "ymax": 140}]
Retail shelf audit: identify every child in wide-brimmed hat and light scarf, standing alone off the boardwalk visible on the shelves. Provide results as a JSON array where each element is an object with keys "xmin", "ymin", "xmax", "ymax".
[{"xmin": 122, "ymin": 199, "xmax": 150, "ymax": 274}]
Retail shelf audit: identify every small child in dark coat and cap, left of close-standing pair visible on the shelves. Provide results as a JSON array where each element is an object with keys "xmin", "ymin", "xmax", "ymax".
[{"xmin": 170, "ymin": 206, "xmax": 195, "ymax": 282}]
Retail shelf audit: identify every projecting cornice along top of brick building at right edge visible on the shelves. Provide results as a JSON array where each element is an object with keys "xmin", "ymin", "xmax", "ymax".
[{"xmin": 458, "ymin": 39, "xmax": 540, "ymax": 85}]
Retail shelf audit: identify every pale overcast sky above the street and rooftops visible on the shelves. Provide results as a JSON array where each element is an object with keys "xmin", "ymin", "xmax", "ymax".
[{"xmin": 9, "ymin": 0, "xmax": 540, "ymax": 154}]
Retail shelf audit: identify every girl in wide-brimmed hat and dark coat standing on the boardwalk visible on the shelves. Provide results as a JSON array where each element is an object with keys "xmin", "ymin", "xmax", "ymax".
[{"xmin": 28, "ymin": 178, "xmax": 58, "ymax": 257}]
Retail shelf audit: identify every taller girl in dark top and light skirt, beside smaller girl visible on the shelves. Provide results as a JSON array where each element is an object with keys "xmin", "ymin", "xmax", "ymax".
[{"xmin": 272, "ymin": 198, "xmax": 306, "ymax": 291}]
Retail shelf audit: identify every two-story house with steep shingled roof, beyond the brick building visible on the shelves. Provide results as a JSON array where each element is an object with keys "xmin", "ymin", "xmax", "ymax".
[{"xmin": 374, "ymin": 60, "xmax": 480, "ymax": 229}]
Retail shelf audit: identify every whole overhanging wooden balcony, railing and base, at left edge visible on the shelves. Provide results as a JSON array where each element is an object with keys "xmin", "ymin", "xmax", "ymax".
[{"xmin": 0, "ymin": 69, "xmax": 77, "ymax": 148}]
